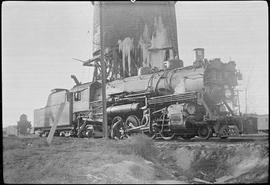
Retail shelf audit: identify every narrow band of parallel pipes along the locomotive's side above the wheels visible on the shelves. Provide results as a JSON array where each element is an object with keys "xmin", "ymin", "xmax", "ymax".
[{"xmin": 148, "ymin": 92, "xmax": 197, "ymax": 105}]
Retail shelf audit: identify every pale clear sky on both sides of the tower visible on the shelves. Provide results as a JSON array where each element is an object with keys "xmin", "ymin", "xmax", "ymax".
[{"xmin": 2, "ymin": 1, "xmax": 268, "ymax": 127}]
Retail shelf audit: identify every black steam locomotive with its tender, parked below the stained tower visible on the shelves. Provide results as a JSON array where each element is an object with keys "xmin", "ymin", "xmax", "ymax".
[{"xmin": 34, "ymin": 48, "xmax": 243, "ymax": 139}]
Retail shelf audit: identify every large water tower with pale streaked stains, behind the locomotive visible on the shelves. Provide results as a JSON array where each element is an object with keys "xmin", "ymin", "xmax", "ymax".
[{"xmin": 90, "ymin": 1, "xmax": 178, "ymax": 79}]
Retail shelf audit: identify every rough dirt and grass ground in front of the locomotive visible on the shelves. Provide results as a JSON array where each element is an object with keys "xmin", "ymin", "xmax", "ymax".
[{"xmin": 3, "ymin": 135, "xmax": 269, "ymax": 184}]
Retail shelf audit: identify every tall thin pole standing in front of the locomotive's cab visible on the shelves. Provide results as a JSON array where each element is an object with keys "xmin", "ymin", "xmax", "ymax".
[{"xmin": 99, "ymin": 1, "xmax": 108, "ymax": 139}]
